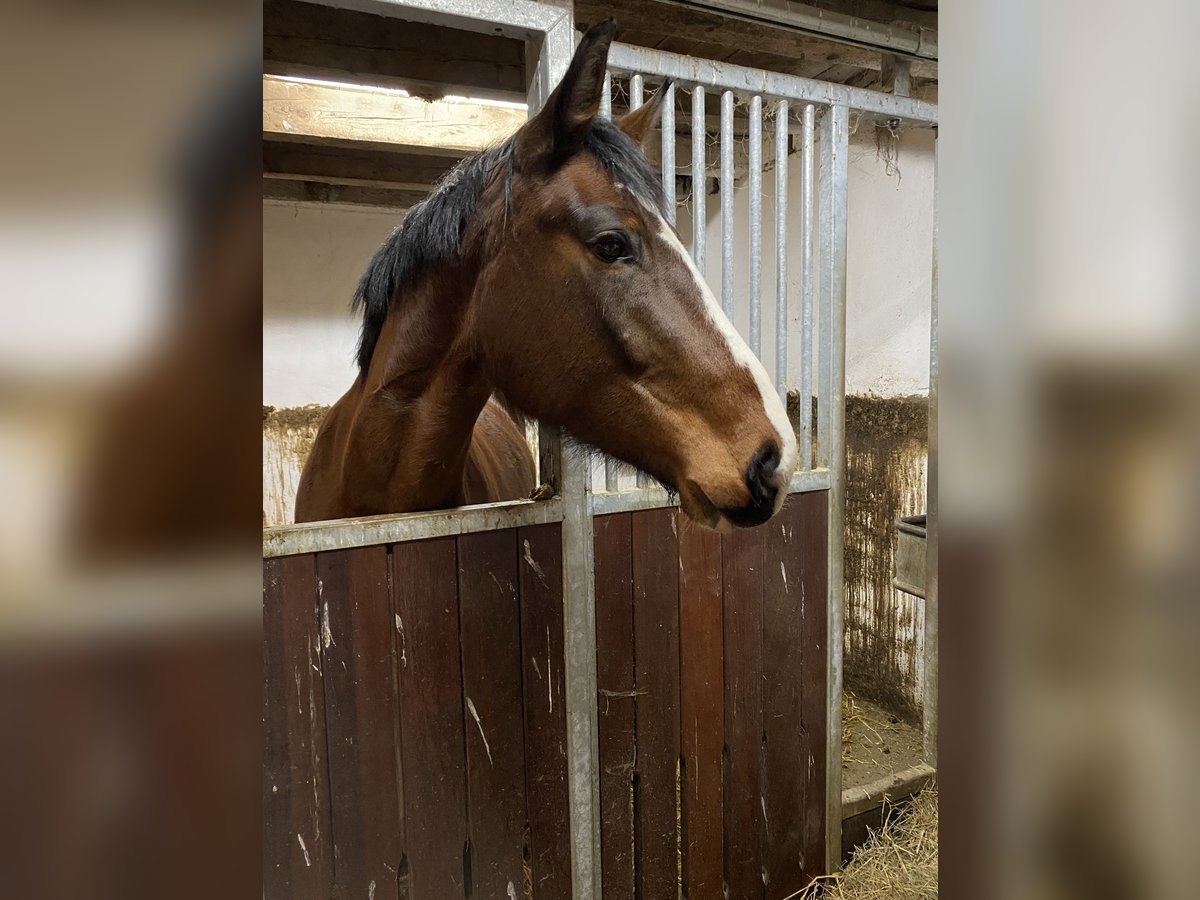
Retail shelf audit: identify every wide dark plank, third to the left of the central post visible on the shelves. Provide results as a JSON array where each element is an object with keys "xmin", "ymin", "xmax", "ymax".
[{"xmin": 391, "ymin": 538, "xmax": 467, "ymax": 900}]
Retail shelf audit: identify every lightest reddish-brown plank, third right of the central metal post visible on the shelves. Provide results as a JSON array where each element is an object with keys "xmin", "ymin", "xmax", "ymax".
[{"xmin": 679, "ymin": 516, "xmax": 725, "ymax": 900}]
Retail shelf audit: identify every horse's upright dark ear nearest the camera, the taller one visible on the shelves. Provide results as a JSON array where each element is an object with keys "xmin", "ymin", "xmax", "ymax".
[{"xmin": 517, "ymin": 18, "xmax": 617, "ymax": 160}]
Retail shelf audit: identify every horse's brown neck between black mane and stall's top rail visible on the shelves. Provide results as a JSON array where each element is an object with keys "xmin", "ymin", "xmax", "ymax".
[{"xmin": 343, "ymin": 274, "xmax": 491, "ymax": 511}]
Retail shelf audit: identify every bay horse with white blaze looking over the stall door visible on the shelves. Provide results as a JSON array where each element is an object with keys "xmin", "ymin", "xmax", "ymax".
[{"xmin": 295, "ymin": 19, "xmax": 797, "ymax": 530}]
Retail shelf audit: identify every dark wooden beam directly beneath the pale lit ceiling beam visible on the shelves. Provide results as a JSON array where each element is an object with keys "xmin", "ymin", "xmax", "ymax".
[{"xmin": 263, "ymin": 140, "xmax": 457, "ymax": 191}]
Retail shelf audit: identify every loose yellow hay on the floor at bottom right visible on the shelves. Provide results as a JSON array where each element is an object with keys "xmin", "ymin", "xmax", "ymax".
[{"xmin": 794, "ymin": 787, "xmax": 937, "ymax": 900}]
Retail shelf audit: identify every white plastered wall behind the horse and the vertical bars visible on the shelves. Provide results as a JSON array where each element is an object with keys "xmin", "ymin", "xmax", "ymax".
[{"xmin": 263, "ymin": 120, "xmax": 934, "ymax": 407}]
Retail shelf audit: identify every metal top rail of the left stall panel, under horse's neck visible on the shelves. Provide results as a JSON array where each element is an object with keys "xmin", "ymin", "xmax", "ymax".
[{"xmin": 263, "ymin": 498, "xmax": 563, "ymax": 557}]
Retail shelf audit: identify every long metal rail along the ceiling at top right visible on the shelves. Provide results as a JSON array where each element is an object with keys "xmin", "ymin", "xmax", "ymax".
[{"xmin": 667, "ymin": 0, "xmax": 937, "ymax": 60}]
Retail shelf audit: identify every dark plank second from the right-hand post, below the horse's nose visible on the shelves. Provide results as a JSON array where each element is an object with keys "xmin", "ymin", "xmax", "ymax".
[{"xmin": 762, "ymin": 497, "xmax": 801, "ymax": 900}]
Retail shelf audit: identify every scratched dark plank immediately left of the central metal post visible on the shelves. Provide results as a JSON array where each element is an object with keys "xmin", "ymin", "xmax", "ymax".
[{"xmin": 517, "ymin": 523, "xmax": 571, "ymax": 900}]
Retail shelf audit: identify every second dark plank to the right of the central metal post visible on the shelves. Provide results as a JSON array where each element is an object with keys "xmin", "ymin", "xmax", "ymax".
[{"xmin": 630, "ymin": 509, "xmax": 680, "ymax": 898}]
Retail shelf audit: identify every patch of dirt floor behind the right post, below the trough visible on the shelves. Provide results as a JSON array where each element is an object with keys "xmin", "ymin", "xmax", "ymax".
[{"xmin": 841, "ymin": 694, "xmax": 922, "ymax": 790}]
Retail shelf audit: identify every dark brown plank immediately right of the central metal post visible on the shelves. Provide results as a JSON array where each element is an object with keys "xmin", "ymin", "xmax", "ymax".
[{"xmin": 594, "ymin": 512, "xmax": 638, "ymax": 900}]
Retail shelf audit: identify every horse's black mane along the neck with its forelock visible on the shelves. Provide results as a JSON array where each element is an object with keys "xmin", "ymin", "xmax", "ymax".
[{"xmin": 352, "ymin": 119, "xmax": 665, "ymax": 376}]
